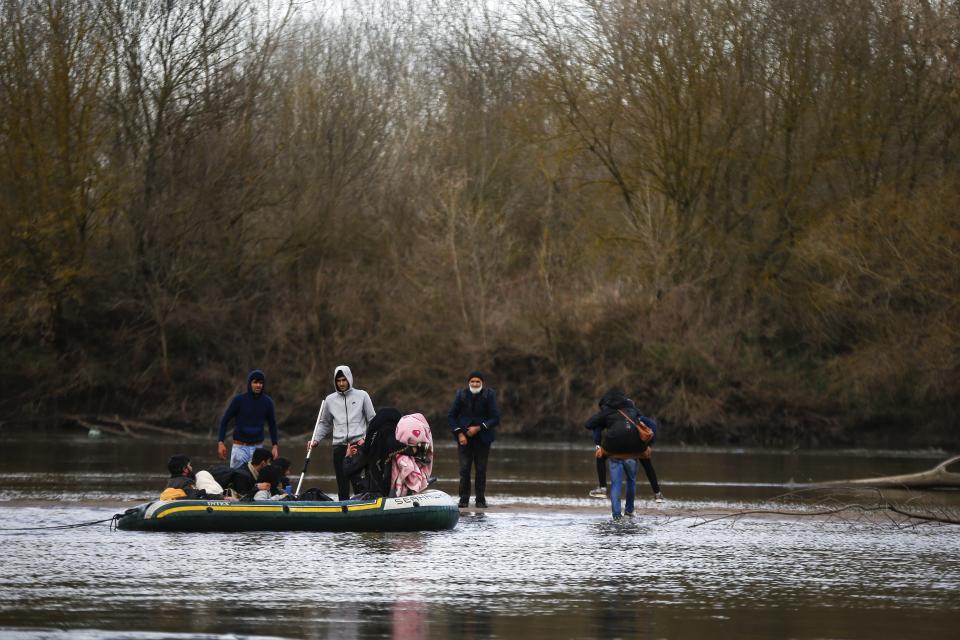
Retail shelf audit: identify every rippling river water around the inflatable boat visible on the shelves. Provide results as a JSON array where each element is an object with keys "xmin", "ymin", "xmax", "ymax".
[{"xmin": 0, "ymin": 434, "xmax": 960, "ymax": 640}]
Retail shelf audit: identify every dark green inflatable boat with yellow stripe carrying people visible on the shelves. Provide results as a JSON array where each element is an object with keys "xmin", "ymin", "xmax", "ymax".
[{"xmin": 114, "ymin": 491, "xmax": 460, "ymax": 531}]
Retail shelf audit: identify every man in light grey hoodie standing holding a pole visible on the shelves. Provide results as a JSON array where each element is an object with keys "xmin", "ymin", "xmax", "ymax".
[{"xmin": 307, "ymin": 364, "xmax": 375, "ymax": 500}]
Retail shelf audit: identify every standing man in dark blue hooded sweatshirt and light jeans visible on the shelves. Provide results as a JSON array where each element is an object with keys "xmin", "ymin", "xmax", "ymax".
[{"xmin": 217, "ymin": 369, "xmax": 280, "ymax": 468}]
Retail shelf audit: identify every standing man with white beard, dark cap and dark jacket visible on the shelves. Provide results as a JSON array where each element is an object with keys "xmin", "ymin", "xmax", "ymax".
[{"xmin": 447, "ymin": 371, "xmax": 500, "ymax": 509}]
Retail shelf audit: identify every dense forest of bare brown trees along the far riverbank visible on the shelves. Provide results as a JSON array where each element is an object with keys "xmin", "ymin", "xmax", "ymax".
[{"xmin": 0, "ymin": 0, "xmax": 960, "ymax": 446}]
